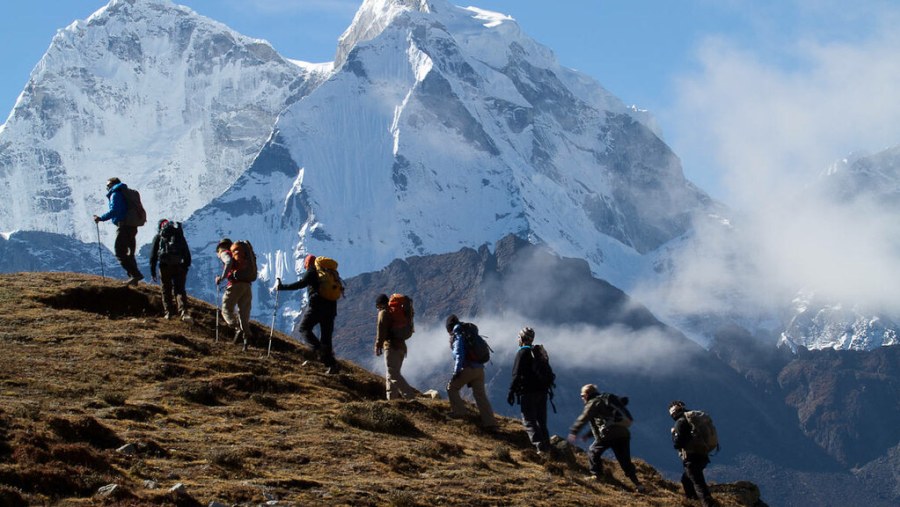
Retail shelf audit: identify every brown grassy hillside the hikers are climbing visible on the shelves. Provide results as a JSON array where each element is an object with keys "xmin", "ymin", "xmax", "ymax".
[{"xmin": 0, "ymin": 273, "xmax": 762, "ymax": 506}]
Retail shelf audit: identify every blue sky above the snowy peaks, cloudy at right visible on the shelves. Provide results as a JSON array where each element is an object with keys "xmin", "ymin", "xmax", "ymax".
[{"xmin": 0, "ymin": 0, "xmax": 900, "ymax": 206}]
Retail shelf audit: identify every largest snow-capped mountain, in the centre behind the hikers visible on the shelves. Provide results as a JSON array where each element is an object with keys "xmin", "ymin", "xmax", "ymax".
[{"xmin": 190, "ymin": 0, "xmax": 711, "ymax": 306}]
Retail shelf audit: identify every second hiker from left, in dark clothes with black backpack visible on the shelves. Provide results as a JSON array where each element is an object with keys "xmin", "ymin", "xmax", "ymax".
[{"xmin": 150, "ymin": 218, "xmax": 194, "ymax": 323}]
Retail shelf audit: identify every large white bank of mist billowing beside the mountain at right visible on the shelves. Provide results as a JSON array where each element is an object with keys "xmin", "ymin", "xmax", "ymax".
[{"xmin": 635, "ymin": 2, "xmax": 900, "ymax": 332}]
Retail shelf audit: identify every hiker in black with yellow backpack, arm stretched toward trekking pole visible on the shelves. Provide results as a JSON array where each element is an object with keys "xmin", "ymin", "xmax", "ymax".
[{"xmin": 275, "ymin": 254, "xmax": 343, "ymax": 375}]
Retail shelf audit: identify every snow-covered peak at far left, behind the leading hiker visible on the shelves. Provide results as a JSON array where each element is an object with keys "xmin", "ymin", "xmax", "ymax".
[{"xmin": 0, "ymin": 0, "xmax": 330, "ymax": 248}]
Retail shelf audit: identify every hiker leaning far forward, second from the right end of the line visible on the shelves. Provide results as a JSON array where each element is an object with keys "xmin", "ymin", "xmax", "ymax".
[{"xmin": 568, "ymin": 384, "xmax": 644, "ymax": 493}]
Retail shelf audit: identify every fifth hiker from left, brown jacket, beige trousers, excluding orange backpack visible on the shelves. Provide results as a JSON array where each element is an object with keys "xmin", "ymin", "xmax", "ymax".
[{"xmin": 375, "ymin": 294, "xmax": 416, "ymax": 400}]
